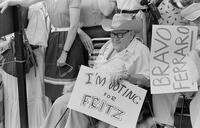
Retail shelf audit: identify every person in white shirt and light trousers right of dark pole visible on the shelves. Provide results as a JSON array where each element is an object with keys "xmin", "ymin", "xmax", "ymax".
[{"xmin": 25, "ymin": 2, "xmax": 52, "ymax": 128}]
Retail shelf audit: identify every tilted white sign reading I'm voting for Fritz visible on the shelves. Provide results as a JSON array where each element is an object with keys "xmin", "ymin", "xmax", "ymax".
[{"xmin": 68, "ymin": 66, "xmax": 146, "ymax": 128}]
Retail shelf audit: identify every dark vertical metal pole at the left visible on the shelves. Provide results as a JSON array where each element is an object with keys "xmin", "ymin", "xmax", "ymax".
[{"xmin": 13, "ymin": 6, "xmax": 28, "ymax": 128}]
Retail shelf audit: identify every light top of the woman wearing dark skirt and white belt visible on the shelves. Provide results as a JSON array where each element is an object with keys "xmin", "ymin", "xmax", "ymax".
[{"xmin": 46, "ymin": 0, "xmax": 81, "ymax": 28}]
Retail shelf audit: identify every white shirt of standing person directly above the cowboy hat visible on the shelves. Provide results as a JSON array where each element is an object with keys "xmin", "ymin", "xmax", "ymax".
[{"xmin": 116, "ymin": 0, "xmax": 146, "ymax": 10}]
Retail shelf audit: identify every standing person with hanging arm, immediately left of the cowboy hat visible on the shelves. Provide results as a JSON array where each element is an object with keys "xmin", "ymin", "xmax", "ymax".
[{"xmin": 78, "ymin": 0, "xmax": 109, "ymax": 53}]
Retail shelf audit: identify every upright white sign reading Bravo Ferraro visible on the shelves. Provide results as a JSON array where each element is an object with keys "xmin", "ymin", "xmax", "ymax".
[{"xmin": 150, "ymin": 25, "xmax": 197, "ymax": 94}]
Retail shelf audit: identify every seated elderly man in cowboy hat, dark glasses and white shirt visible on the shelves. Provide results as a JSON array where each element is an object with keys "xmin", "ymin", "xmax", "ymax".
[{"xmin": 65, "ymin": 14, "xmax": 149, "ymax": 128}]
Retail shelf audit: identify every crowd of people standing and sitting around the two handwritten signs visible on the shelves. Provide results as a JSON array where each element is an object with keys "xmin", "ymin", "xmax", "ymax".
[{"xmin": 0, "ymin": 0, "xmax": 200, "ymax": 128}]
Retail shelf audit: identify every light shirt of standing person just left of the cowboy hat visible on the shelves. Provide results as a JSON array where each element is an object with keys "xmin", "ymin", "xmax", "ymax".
[{"xmin": 80, "ymin": 0, "xmax": 104, "ymax": 27}]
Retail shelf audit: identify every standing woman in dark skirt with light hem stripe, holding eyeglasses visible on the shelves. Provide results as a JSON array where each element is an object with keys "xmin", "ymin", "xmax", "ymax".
[{"xmin": 45, "ymin": 0, "xmax": 88, "ymax": 99}]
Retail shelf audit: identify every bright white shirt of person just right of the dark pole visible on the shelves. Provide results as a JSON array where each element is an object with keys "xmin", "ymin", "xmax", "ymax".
[{"xmin": 26, "ymin": 2, "xmax": 49, "ymax": 47}]
